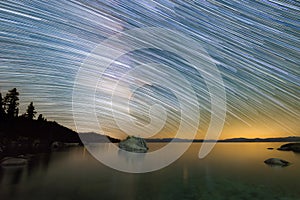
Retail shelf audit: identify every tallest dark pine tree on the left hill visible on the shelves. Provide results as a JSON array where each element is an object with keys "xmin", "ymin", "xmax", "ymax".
[{"xmin": 4, "ymin": 88, "xmax": 19, "ymax": 119}]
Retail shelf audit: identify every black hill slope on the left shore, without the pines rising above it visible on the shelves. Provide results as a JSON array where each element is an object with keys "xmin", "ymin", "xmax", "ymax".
[{"xmin": 0, "ymin": 117, "xmax": 82, "ymax": 157}]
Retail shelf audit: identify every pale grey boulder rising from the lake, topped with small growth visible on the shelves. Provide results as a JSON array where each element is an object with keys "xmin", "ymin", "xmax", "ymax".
[{"xmin": 119, "ymin": 136, "xmax": 149, "ymax": 153}]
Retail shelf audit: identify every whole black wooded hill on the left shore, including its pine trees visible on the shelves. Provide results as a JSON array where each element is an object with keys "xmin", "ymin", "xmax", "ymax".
[{"xmin": 0, "ymin": 88, "xmax": 81, "ymax": 153}]
